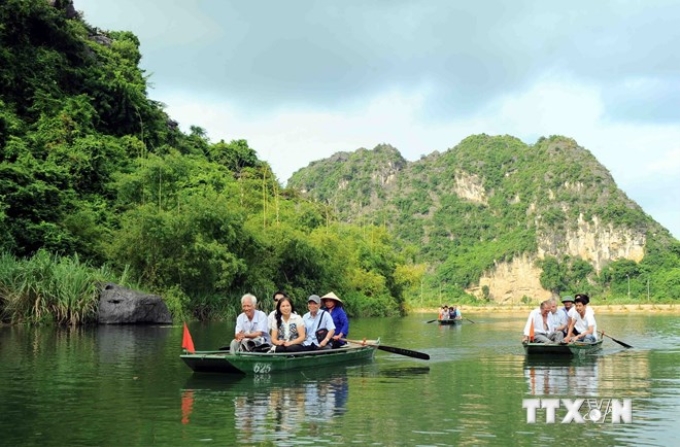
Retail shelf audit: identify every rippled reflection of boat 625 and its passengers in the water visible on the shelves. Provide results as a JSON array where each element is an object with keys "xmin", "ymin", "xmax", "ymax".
[{"xmin": 181, "ymin": 364, "xmax": 429, "ymax": 445}]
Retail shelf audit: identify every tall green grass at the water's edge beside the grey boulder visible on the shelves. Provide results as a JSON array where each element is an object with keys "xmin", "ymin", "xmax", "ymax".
[{"xmin": 0, "ymin": 250, "xmax": 134, "ymax": 326}]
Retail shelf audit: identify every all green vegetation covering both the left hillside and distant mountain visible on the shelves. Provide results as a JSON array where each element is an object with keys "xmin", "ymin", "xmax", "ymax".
[{"xmin": 0, "ymin": 0, "xmax": 680, "ymax": 325}]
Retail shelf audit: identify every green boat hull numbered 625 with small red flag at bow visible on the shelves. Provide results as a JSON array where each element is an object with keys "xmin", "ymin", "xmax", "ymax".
[{"xmin": 180, "ymin": 341, "xmax": 379, "ymax": 375}]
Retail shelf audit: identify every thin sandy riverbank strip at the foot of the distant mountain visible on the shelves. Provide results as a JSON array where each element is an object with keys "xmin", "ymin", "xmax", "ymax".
[{"xmin": 413, "ymin": 304, "xmax": 680, "ymax": 316}]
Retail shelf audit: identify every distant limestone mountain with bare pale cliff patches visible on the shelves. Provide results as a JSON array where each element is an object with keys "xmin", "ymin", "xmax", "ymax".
[{"xmin": 288, "ymin": 135, "xmax": 680, "ymax": 302}]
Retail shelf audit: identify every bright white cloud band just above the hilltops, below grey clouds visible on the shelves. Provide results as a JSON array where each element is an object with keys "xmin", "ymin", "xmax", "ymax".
[{"xmin": 164, "ymin": 80, "xmax": 680, "ymax": 242}]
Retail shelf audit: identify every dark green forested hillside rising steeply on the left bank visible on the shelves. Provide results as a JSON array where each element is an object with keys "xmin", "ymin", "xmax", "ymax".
[{"xmin": 0, "ymin": 0, "xmax": 420, "ymax": 324}]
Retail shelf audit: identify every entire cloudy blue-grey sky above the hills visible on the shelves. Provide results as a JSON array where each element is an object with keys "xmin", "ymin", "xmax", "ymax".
[{"xmin": 74, "ymin": 0, "xmax": 680, "ymax": 238}]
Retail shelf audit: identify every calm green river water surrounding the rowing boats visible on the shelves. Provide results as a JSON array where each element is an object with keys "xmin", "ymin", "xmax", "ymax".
[{"xmin": 0, "ymin": 314, "xmax": 680, "ymax": 447}]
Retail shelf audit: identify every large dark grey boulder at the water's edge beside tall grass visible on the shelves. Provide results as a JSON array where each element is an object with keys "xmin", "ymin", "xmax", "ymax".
[{"xmin": 99, "ymin": 284, "xmax": 172, "ymax": 324}]
